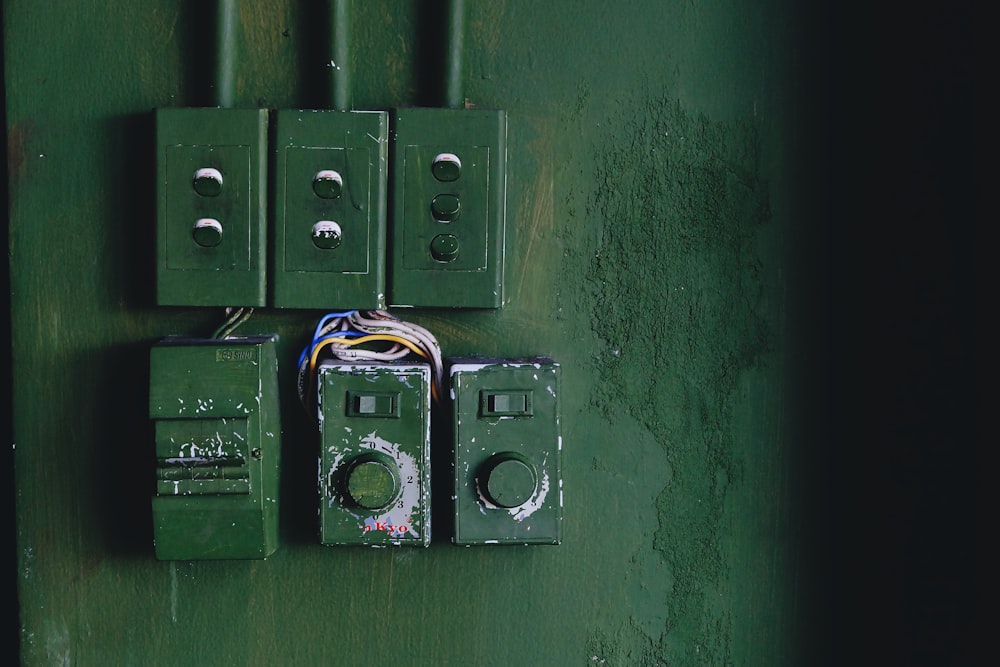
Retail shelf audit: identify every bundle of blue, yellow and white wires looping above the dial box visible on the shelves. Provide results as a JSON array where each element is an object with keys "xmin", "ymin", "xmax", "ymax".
[{"xmin": 299, "ymin": 310, "xmax": 444, "ymax": 410}]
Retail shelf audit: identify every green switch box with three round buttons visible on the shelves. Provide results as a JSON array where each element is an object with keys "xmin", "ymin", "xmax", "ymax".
[{"xmin": 389, "ymin": 109, "xmax": 507, "ymax": 308}]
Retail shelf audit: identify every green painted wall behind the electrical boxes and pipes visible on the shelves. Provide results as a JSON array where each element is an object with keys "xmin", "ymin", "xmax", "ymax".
[{"xmin": 3, "ymin": 0, "xmax": 803, "ymax": 666}]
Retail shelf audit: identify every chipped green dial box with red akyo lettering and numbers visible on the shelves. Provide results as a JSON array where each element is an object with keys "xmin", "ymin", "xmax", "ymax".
[{"xmin": 318, "ymin": 361, "xmax": 431, "ymax": 546}]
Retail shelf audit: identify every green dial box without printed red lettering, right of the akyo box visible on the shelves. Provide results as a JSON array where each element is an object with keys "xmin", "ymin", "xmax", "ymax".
[{"xmin": 450, "ymin": 358, "xmax": 562, "ymax": 545}]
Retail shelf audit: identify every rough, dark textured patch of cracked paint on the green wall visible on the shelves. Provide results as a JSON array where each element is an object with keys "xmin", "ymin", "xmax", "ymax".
[{"xmin": 580, "ymin": 94, "xmax": 775, "ymax": 665}]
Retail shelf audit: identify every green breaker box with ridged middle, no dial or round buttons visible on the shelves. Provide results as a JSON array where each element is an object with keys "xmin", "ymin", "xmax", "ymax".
[{"xmin": 149, "ymin": 336, "xmax": 281, "ymax": 560}]
